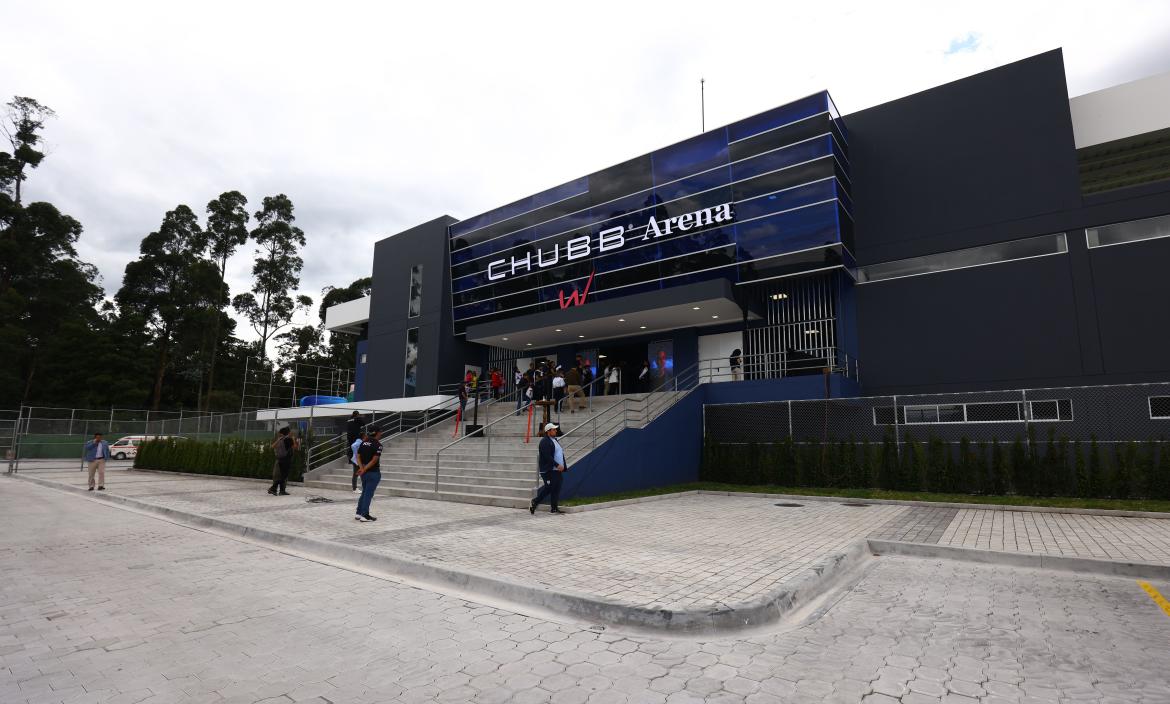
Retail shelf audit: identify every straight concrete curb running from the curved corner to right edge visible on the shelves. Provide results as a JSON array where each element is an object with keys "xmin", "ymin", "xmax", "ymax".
[{"xmin": 867, "ymin": 539, "xmax": 1170, "ymax": 579}]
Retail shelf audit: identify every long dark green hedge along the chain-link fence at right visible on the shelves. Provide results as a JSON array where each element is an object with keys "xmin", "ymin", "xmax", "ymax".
[{"xmin": 700, "ymin": 430, "xmax": 1170, "ymax": 499}]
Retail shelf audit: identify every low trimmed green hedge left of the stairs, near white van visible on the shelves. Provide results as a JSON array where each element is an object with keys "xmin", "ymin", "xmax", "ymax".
[{"xmin": 135, "ymin": 439, "xmax": 304, "ymax": 482}]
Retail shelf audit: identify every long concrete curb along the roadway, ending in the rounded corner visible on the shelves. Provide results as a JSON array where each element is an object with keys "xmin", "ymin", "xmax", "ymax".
[{"xmin": 12, "ymin": 475, "xmax": 869, "ymax": 635}]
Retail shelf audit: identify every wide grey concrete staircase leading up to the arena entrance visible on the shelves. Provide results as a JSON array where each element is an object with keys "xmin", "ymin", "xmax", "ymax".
[{"xmin": 304, "ymin": 392, "xmax": 669, "ymax": 508}]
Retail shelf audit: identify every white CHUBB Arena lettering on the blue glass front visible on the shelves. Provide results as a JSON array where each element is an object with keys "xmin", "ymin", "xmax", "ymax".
[{"xmin": 488, "ymin": 202, "xmax": 735, "ymax": 281}]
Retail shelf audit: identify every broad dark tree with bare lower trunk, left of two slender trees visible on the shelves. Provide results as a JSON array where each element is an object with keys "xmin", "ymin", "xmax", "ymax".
[{"xmin": 115, "ymin": 205, "xmax": 220, "ymax": 410}]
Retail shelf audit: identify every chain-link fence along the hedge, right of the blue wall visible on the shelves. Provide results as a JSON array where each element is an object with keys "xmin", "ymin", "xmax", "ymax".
[{"xmin": 703, "ymin": 384, "xmax": 1170, "ymax": 498}]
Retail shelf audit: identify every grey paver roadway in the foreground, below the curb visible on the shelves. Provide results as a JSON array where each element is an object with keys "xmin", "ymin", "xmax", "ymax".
[{"xmin": 0, "ymin": 475, "xmax": 1170, "ymax": 704}]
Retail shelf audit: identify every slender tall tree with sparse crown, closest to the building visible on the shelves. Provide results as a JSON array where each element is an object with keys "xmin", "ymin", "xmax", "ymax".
[{"xmin": 232, "ymin": 193, "xmax": 312, "ymax": 359}]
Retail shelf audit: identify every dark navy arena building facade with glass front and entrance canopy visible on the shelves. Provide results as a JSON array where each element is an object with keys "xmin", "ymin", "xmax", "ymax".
[{"xmin": 343, "ymin": 50, "xmax": 1170, "ymax": 400}]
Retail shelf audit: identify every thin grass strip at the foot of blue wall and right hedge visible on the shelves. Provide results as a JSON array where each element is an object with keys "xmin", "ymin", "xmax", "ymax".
[{"xmin": 560, "ymin": 482, "xmax": 1170, "ymax": 512}]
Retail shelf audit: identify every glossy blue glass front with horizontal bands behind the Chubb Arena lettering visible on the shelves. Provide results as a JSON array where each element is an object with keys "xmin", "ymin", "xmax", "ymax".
[{"xmin": 449, "ymin": 92, "xmax": 852, "ymax": 333}]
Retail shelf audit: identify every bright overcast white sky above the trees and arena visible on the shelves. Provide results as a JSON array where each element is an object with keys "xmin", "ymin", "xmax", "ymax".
[{"xmin": 0, "ymin": 0, "xmax": 1170, "ymax": 337}]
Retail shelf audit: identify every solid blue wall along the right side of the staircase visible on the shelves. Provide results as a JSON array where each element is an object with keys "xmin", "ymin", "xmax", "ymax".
[{"xmin": 562, "ymin": 374, "xmax": 858, "ymax": 498}]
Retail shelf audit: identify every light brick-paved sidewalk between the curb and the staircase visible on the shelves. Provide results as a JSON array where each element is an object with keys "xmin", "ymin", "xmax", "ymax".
[{"xmin": 9, "ymin": 471, "xmax": 1170, "ymax": 627}]
